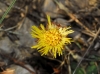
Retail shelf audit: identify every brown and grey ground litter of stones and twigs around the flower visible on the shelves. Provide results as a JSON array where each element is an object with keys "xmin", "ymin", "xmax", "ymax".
[{"xmin": 0, "ymin": 0, "xmax": 100, "ymax": 74}]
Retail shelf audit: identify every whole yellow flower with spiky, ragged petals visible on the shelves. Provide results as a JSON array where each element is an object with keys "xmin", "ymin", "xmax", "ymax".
[{"xmin": 31, "ymin": 15, "xmax": 73, "ymax": 58}]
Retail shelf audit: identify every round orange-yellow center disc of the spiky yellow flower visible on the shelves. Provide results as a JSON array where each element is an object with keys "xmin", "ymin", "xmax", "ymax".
[{"xmin": 45, "ymin": 29, "xmax": 61, "ymax": 46}]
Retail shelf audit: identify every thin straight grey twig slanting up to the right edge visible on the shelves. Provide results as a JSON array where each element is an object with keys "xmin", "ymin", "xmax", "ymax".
[{"xmin": 73, "ymin": 28, "xmax": 100, "ymax": 74}]
